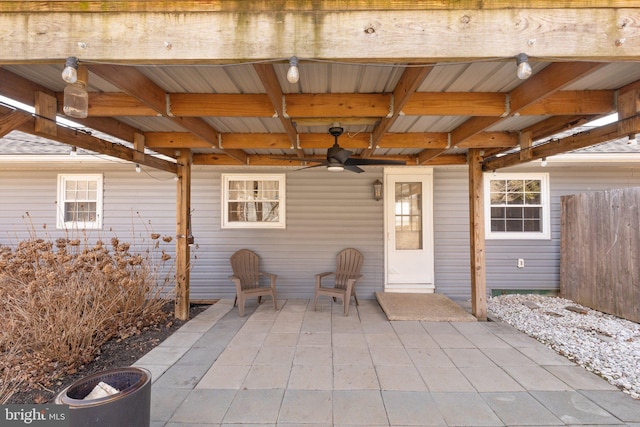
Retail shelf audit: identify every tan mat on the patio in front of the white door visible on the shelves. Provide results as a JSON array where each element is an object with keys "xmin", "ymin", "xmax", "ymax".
[{"xmin": 376, "ymin": 292, "xmax": 477, "ymax": 322}]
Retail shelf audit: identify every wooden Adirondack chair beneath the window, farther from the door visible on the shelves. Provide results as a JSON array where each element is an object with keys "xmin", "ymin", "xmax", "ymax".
[{"xmin": 229, "ymin": 249, "xmax": 278, "ymax": 317}]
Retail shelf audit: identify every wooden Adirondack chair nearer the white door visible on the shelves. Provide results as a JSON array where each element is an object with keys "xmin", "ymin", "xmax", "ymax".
[{"xmin": 313, "ymin": 248, "xmax": 364, "ymax": 316}]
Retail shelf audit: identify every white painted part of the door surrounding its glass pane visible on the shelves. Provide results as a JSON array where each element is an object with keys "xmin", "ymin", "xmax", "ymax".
[{"xmin": 384, "ymin": 166, "xmax": 435, "ymax": 293}]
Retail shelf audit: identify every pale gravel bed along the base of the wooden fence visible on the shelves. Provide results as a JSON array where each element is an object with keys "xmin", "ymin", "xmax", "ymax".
[{"xmin": 487, "ymin": 295, "xmax": 640, "ymax": 399}]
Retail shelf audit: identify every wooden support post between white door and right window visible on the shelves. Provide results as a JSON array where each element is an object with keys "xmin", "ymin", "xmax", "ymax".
[{"xmin": 468, "ymin": 148, "xmax": 487, "ymax": 321}]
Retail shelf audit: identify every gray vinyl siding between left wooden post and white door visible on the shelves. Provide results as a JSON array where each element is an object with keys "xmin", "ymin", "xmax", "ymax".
[{"xmin": 190, "ymin": 167, "xmax": 384, "ymax": 299}]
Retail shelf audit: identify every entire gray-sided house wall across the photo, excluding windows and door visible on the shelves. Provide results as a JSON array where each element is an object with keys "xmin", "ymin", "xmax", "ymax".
[{"xmin": 0, "ymin": 162, "xmax": 640, "ymax": 300}]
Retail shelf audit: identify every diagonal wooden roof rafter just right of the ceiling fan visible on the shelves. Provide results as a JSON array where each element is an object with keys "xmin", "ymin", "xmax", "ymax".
[{"xmin": 362, "ymin": 67, "xmax": 433, "ymax": 158}]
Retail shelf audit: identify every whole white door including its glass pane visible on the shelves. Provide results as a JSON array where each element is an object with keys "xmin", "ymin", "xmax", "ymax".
[{"xmin": 384, "ymin": 167, "xmax": 435, "ymax": 293}]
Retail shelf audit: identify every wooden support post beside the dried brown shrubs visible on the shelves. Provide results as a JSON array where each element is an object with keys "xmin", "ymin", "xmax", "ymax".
[{"xmin": 175, "ymin": 150, "xmax": 193, "ymax": 320}]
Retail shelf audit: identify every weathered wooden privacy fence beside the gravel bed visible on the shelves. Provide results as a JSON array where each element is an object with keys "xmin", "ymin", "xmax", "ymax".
[{"xmin": 560, "ymin": 188, "xmax": 640, "ymax": 322}]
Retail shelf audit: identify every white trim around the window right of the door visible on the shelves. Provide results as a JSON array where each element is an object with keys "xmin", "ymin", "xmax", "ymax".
[{"xmin": 483, "ymin": 172, "xmax": 551, "ymax": 240}]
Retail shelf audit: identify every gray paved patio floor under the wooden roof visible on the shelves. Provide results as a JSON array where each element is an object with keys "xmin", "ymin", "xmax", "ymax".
[{"xmin": 134, "ymin": 298, "xmax": 640, "ymax": 427}]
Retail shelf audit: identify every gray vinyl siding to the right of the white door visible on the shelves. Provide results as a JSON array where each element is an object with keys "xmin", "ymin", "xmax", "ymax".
[{"xmin": 434, "ymin": 163, "xmax": 640, "ymax": 298}]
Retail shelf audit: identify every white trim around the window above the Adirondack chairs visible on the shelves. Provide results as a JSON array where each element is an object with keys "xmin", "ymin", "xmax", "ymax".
[{"xmin": 220, "ymin": 173, "xmax": 286, "ymax": 229}]
